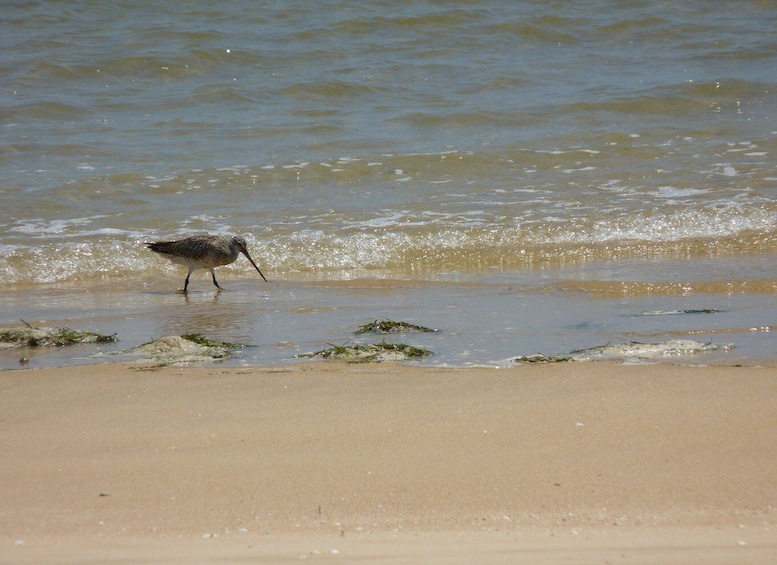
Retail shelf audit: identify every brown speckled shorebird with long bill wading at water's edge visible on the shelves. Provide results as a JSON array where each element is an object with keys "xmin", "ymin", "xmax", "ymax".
[{"xmin": 146, "ymin": 235, "xmax": 267, "ymax": 292}]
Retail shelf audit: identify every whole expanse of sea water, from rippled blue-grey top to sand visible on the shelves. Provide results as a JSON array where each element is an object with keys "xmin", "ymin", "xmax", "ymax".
[{"xmin": 0, "ymin": 0, "xmax": 777, "ymax": 367}]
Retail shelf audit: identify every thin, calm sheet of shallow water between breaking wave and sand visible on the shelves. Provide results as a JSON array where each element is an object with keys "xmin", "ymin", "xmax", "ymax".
[{"xmin": 0, "ymin": 258, "xmax": 777, "ymax": 369}]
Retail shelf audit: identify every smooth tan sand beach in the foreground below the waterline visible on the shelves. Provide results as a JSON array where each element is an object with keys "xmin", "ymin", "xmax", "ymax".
[{"xmin": 0, "ymin": 363, "xmax": 777, "ymax": 564}]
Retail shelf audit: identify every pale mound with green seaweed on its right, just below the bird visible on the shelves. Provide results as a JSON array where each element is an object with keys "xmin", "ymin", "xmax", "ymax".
[{"xmin": 120, "ymin": 333, "xmax": 244, "ymax": 367}]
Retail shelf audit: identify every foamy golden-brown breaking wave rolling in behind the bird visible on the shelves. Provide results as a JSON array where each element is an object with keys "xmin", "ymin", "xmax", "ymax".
[{"xmin": 0, "ymin": 207, "xmax": 777, "ymax": 284}]
